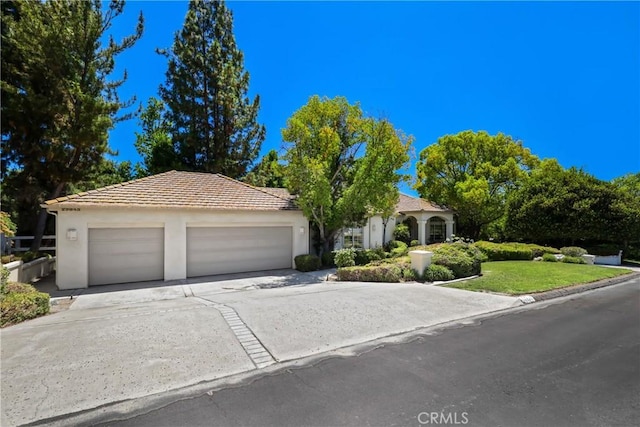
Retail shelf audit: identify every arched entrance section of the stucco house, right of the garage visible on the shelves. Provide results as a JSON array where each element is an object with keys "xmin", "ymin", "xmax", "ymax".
[{"xmin": 335, "ymin": 194, "xmax": 455, "ymax": 249}]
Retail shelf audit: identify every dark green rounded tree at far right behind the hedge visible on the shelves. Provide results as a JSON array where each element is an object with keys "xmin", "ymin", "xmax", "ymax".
[{"xmin": 506, "ymin": 159, "xmax": 640, "ymax": 244}]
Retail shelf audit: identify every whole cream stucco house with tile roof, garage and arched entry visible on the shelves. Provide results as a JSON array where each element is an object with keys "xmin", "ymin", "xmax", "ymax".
[{"xmin": 43, "ymin": 171, "xmax": 453, "ymax": 289}]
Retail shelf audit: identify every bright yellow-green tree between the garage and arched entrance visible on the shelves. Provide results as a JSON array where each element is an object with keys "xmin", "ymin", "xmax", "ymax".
[{"xmin": 282, "ymin": 96, "xmax": 412, "ymax": 251}]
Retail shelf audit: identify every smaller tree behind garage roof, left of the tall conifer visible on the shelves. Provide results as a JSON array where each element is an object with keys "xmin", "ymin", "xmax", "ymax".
[{"xmin": 134, "ymin": 97, "xmax": 182, "ymax": 177}]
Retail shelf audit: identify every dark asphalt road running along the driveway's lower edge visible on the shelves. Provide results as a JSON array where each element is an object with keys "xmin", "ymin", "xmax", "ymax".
[{"xmin": 100, "ymin": 279, "xmax": 640, "ymax": 427}]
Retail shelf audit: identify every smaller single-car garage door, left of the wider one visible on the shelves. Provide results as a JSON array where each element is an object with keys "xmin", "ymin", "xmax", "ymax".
[{"xmin": 89, "ymin": 228, "xmax": 164, "ymax": 285}]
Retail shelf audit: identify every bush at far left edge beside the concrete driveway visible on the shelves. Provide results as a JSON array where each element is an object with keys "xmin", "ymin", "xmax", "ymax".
[{"xmin": 0, "ymin": 283, "xmax": 49, "ymax": 326}]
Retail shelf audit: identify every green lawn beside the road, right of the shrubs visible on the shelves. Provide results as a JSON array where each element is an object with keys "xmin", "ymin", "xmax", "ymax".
[{"xmin": 448, "ymin": 261, "xmax": 631, "ymax": 295}]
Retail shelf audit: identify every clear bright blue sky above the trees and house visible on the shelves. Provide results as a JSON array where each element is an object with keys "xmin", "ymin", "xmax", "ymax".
[{"xmin": 110, "ymin": 1, "xmax": 640, "ymax": 190}]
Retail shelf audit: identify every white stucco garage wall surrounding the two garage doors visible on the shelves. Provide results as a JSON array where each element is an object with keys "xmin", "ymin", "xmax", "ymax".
[{"xmin": 56, "ymin": 207, "xmax": 309, "ymax": 289}]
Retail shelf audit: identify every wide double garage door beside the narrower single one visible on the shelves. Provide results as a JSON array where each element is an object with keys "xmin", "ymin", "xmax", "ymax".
[{"xmin": 187, "ymin": 227, "xmax": 293, "ymax": 277}]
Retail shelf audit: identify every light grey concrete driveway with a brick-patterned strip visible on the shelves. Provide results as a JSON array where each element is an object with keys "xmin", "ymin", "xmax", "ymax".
[{"xmin": 0, "ymin": 270, "xmax": 521, "ymax": 426}]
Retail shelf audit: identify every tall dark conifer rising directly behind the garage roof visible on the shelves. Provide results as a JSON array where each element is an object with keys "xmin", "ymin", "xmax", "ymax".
[{"xmin": 160, "ymin": 0, "xmax": 265, "ymax": 178}]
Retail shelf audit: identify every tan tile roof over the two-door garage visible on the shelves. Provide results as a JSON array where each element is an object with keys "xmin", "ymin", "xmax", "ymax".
[{"xmin": 43, "ymin": 171, "xmax": 298, "ymax": 211}]
